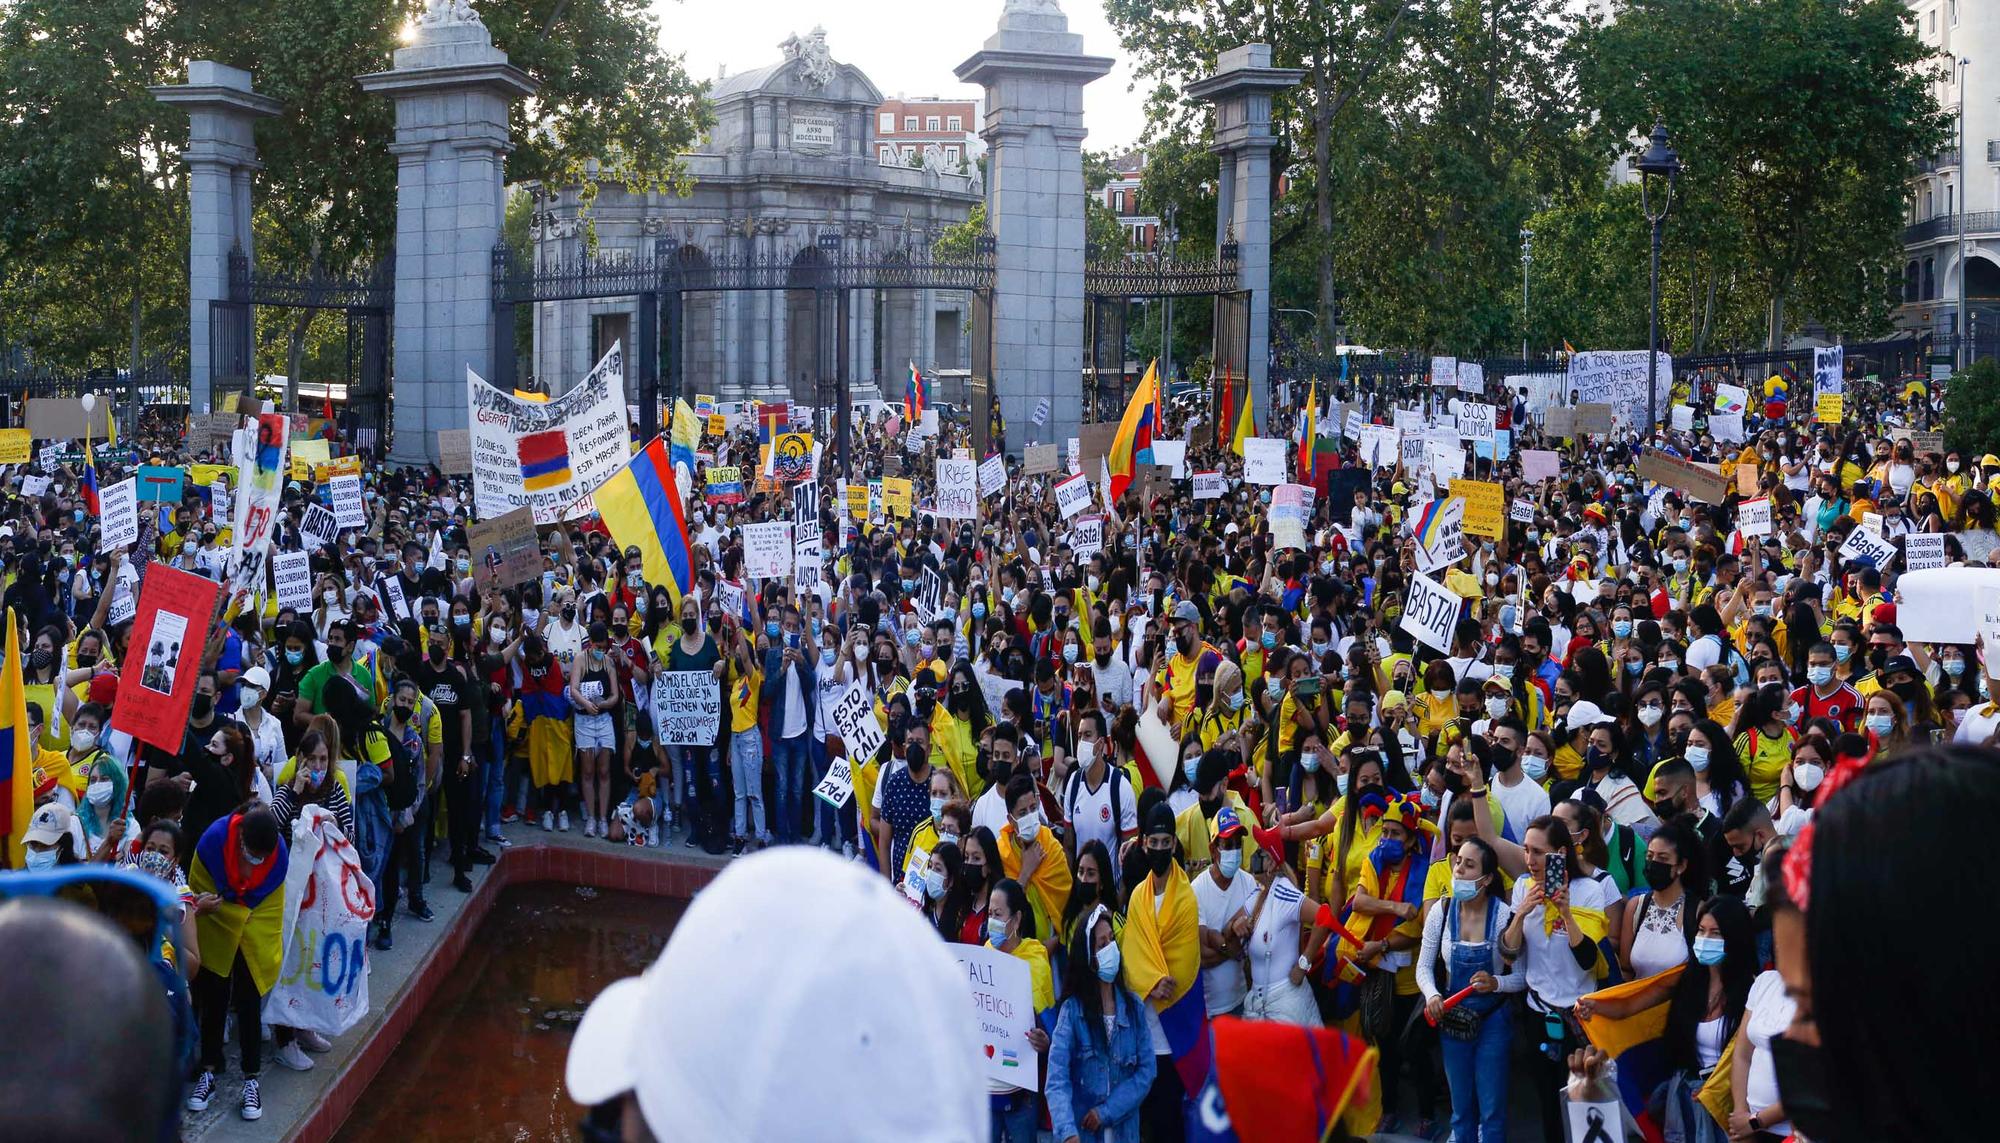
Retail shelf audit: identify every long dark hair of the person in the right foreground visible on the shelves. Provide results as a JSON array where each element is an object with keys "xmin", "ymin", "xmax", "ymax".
[{"xmin": 1808, "ymin": 747, "xmax": 2000, "ymax": 1139}]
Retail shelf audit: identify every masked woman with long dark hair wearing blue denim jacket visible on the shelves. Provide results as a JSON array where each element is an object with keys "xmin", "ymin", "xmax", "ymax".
[{"xmin": 1046, "ymin": 905, "xmax": 1156, "ymax": 1143}]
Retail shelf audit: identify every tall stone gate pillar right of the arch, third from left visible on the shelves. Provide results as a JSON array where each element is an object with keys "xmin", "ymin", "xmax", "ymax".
[{"xmin": 958, "ymin": 4, "xmax": 1114, "ymax": 440}]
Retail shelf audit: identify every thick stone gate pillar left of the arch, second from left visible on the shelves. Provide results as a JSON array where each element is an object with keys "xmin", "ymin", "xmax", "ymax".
[{"xmin": 360, "ymin": 10, "xmax": 536, "ymax": 464}]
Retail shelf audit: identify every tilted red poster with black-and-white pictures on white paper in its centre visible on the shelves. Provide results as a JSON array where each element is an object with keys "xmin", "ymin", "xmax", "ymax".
[{"xmin": 112, "ymin": 564, "xmax": 222, "ymax": 751}]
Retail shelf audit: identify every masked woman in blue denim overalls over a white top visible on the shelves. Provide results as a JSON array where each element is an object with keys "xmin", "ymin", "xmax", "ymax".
[{"xmin": 1416, "ymin": 837, "xmax": 1528, "ymax": 1143}]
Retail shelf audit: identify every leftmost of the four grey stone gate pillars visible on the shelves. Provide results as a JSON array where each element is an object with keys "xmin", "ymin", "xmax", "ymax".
[{"xmin": 152, "ymin": 60, "xmax": 284, "ymax": 412}]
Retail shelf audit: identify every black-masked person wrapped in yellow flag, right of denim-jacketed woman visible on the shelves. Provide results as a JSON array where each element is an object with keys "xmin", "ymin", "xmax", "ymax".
[{"xmin": 1118, "ymin": 803, "xmax": 1208, "ymax": 1139}]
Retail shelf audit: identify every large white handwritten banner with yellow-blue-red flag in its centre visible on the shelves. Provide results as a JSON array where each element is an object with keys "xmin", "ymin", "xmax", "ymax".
[{"xmin": 466, "ymin": 344, "xmax": 632, "ymax": 524}]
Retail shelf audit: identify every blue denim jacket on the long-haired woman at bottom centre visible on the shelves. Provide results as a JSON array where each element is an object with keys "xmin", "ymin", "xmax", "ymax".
[{"xmin": 1044, "ymin": 983, "xmax": 1154, "ymax": 1143}]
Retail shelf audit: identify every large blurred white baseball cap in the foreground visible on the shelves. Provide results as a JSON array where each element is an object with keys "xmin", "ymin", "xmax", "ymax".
[{"xmin": 564, "ymin": 847, "xmax": 990, "ymax": 1143}]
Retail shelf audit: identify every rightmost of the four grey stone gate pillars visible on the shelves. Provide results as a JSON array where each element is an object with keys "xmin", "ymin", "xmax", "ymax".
[{"xmin": 1188, "ymin": 44, "xmax": 1304, "ymax": 435}]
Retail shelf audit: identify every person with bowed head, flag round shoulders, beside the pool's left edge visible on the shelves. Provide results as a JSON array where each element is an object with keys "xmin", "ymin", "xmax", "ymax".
[{"xmin": 188, "ymin": 807, "xmax": 290, "ymax": 1119}]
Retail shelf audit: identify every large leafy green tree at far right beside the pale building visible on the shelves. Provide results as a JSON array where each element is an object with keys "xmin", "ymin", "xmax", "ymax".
[{"xmin": 1578, "ymin": 0, "xmax": 1950, "ymax": 350}]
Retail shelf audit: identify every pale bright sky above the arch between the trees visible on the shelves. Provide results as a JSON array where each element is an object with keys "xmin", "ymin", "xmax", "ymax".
[{"xmin": 654, "ymin": 0, "xmax": 1146, "ymax": 152}]
